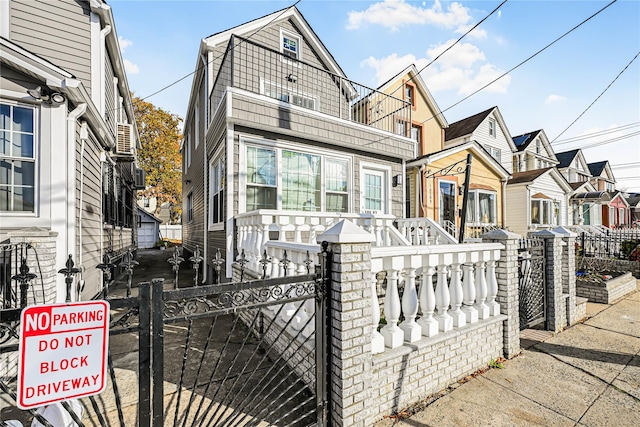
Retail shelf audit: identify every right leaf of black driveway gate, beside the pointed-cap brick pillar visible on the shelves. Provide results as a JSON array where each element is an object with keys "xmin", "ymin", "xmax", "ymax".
[{"xmin": 152, "ymin": 247, "xmax": 328, "ymax": 427}]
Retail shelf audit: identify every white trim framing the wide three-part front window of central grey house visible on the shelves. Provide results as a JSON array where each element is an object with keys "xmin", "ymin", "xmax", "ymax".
[{"xmin": 238, "ymin": 136, "xmax": 352, "ymax": 213}]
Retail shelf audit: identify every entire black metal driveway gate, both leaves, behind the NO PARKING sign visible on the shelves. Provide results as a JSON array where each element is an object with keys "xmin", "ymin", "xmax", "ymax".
[{"xmin": 0, "ymin": 245, "xmax": 330, "ymax": 427}]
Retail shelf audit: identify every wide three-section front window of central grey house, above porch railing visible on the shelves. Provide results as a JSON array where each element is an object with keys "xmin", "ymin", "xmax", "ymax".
[{"xmin": 246, "ymin": 145, "xmax": 350, "ymax": 212}]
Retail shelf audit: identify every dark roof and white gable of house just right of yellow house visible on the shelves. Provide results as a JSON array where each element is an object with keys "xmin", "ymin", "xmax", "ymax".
[{"xmin": 444, "ymin": 107, "xmax": 517, "ymax": 173}]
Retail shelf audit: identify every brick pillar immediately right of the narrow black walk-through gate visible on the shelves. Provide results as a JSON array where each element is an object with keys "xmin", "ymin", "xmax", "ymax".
[{"xmin": 531, "ymin": 230, "xmax": 575, "ymax": 332}]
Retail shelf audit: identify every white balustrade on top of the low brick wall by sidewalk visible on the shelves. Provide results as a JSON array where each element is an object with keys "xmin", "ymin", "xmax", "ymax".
[{"xmin": 371, "ymin": 243, "xmax": 502, "ymax": 353}]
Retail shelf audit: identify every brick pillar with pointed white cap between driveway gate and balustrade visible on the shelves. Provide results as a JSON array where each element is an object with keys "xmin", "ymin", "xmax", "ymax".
[{"xmin": 318, "ymin": 220, "xmax": 375, "ymax": 427}]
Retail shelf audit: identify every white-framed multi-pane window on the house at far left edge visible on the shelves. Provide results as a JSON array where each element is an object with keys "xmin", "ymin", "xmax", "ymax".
[{"xmin": 0, "ymin": 104, "xmax": 36, "ymax": 212}]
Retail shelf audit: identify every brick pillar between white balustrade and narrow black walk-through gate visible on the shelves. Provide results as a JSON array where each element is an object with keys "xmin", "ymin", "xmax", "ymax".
[{"xmin": 482, "ymin": 230, "xmax": 521, "ymax": 359}]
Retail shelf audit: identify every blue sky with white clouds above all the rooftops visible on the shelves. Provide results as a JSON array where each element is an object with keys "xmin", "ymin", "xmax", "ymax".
[{"xmin": 108, "ymin": 0, "xmax": 640, "ymax": 192}]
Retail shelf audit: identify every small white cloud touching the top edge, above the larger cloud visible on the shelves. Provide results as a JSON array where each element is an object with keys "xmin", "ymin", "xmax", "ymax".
[{"xmin": 347, "ymin": 0, "xmax": 471, "ymax": 32}]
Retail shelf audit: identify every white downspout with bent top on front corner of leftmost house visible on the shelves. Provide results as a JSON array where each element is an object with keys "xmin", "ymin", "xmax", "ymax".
[{"xmin": 65, "ymin": 102, "xmax": 87, "ymax": 302}]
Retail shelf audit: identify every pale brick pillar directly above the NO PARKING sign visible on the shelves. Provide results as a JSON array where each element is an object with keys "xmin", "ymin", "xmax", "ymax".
[{"xmin": 9, "ymin": 227, "xmax": 58, "ymax": 305}]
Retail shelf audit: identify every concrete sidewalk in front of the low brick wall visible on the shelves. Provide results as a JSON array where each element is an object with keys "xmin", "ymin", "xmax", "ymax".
[{"xmin": 375, "ymin": 281, "xmax": 640, "ymax": 427}]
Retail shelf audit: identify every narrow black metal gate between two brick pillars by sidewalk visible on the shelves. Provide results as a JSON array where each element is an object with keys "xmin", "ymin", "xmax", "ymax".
[{"xmin": 518, "ymin": 238, "xmax": 546, "ymax": 330}]
